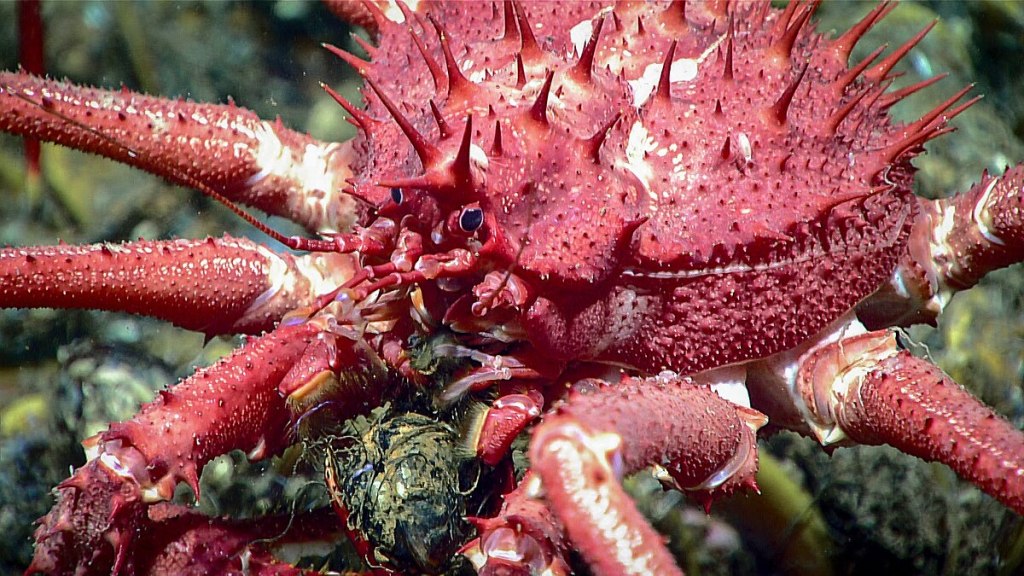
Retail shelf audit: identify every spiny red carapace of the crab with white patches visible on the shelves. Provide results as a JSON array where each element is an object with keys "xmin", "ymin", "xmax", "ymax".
[{"xmin": 347, "ymin": 2, "xmax": 958, "ymax": 373}]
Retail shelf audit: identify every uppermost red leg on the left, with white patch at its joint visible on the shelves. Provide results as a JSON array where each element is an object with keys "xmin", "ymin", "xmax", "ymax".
[{"xmin": 0, "ymin": 72, "xmax": 356, "ymax": 233}]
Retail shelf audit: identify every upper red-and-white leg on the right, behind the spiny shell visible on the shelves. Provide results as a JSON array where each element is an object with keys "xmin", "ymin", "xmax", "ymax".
[{"xmin": 857, "ymin": 164, "xmax": 1024, "ymax": 328}]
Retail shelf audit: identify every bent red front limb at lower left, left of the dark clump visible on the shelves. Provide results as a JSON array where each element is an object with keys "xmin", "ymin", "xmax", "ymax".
[{"xmin": 30, "ymin": 323, "xmax": 322, "ymax": 574}]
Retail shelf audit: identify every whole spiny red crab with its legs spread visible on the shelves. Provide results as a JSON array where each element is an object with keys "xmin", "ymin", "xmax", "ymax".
[{"xmin": 0, "ymin": 1, "xmax": 1024, "ymax": 574}]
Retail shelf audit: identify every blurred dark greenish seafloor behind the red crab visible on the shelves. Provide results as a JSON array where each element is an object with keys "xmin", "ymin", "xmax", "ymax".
[{"xmin": 0, "ymin": 0, "xmax": 1024, "ymax": 575}]
